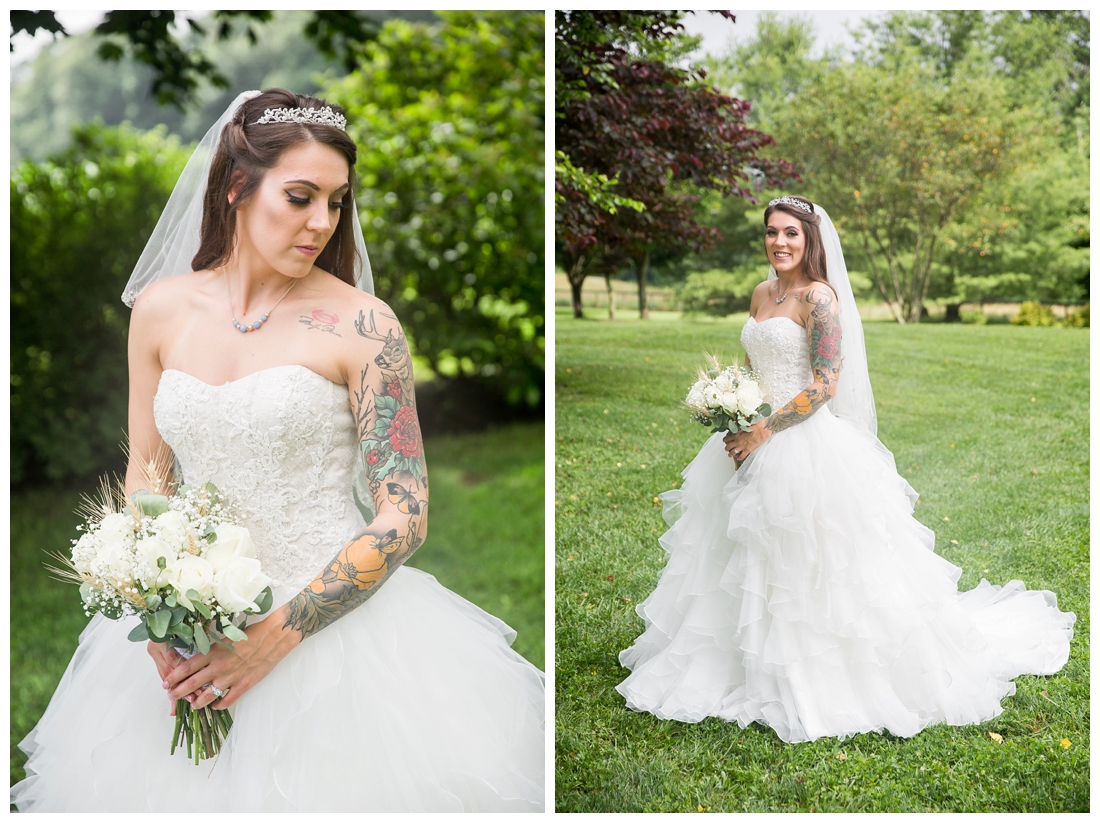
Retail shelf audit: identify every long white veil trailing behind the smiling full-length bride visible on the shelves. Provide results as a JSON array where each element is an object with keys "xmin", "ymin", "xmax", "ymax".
[{"xmin": 768, "ymin": 202, "xmax": 879, "ymax": 437}]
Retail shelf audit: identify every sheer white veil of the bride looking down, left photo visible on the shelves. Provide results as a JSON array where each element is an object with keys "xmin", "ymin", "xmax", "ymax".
[{"xmin": 122, "ymin": 91, "xmax": 374, "ymax": 308}]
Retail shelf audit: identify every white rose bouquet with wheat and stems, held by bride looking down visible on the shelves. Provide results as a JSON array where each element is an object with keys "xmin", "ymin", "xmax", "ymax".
[{"xmin": 51, "ymin": 452, "xmax": 272, "ymax": 764}]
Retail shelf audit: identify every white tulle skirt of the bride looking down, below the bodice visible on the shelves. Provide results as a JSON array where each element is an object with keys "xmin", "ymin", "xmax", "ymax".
[{"xmin": 12, "ymin": 568, "xmax": 545, "ymax": 812}]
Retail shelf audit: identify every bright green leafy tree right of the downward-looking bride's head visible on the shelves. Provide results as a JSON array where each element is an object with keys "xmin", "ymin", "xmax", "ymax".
[{"xmin": 326, "ymin": 12, "xmax": 546, "ymax": 405}]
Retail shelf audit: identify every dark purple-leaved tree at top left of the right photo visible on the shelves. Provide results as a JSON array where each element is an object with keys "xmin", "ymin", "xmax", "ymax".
[{"xmin": 556, "ymin": 11, "xmax": 793, "ymax": 318}]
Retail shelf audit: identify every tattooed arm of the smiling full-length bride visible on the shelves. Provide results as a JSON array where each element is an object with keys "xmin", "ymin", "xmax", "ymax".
[{"xmin": 725, "ymin": 284, "xmax": 840, "ymax": 460}]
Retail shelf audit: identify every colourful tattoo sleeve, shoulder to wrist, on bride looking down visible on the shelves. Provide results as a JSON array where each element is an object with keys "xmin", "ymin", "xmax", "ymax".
[{"xmin": 284, "ymin": 311, "xmax": 428, "ymax": 637}]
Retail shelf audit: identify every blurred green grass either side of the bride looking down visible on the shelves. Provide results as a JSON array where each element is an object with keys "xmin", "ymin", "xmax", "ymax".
[{"xmin": 9, "ymin": 424, "xmax": 546, "ymax": 783}]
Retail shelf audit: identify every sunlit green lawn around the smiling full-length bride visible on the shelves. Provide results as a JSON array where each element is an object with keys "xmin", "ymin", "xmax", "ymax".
[{"xmin": 556, "ymin": 315, "xmax": 1089, "ymax": 812}]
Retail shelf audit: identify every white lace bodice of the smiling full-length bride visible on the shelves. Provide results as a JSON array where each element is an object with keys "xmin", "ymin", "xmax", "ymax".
[{"xmin": 741, "ymin": 317, "xmax": 813, "ymax": 412}]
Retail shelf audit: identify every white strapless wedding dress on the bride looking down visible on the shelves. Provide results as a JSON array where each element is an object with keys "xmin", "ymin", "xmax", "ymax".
[{"xmin": 12, "ymin": 365, "xmax": 545, "ymax": 812}]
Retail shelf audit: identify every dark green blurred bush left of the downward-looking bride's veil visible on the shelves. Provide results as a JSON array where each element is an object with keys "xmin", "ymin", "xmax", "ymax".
[{"xmin": 10, "ymin": 124, "xmax": 189, "ymax": 483}]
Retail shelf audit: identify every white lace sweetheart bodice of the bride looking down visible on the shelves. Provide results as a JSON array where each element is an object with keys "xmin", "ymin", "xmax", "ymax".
[{"xmin": 153, "ymin": 365, "xmax": 363, "ymax": 604}]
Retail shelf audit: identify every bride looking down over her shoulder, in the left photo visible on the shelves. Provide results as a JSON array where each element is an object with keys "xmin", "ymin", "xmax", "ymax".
[{"xmin": 12, "ymin": 89, "xmax": 545, "ymax": 812}]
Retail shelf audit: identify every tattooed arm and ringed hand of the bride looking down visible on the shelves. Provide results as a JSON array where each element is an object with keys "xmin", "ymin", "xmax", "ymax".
[{"xmin": 168, "ymin": 305, "xmax": 428, "ymax": 709}]
